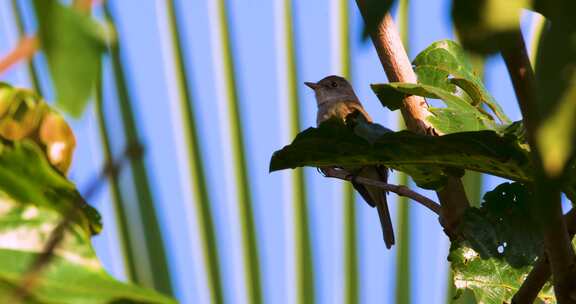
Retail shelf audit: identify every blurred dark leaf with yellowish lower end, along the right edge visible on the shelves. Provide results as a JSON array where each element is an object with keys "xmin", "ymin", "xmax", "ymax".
[{"xmin": 535, "ymin": 1, "xmax": 576, "ymax": 176}]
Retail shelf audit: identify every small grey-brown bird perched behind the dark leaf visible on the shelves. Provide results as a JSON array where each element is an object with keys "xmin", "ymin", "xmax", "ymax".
[{"xmin": 304, "ymin": 75, "xmax": 395, "ymax": 249}]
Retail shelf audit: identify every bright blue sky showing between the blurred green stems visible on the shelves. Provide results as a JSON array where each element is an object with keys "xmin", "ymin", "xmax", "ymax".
[{"xmin": 0, "ymin": 0, "xmax": 530, "ymax": 303}]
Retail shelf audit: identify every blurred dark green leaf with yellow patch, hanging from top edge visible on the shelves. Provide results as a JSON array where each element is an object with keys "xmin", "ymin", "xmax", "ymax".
[{"xmin": 452, "ymin": 0, "xmax": 531, "ymax": 54}]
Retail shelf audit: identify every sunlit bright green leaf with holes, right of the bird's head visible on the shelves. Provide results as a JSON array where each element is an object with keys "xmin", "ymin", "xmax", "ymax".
[{"xmin": 372, "ymin": 40, "xmax": 510, "ymax": 134}]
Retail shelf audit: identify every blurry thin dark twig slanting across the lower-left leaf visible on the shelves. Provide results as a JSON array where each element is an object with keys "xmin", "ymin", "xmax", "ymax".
[{"xmin": 11, "ymin": 145, "xmax": 142, "ymax": 303}]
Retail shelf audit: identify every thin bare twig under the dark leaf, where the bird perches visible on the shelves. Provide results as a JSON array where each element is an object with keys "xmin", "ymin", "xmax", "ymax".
[{"xmin": 323, "ymin": 168, "xmax": 442, "ymax": 214}]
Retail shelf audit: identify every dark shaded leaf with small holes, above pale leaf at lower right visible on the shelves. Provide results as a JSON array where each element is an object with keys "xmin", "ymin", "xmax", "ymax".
[{"xmin": 458, "ymin": 183, "xmax": 543, "ymax": 268}]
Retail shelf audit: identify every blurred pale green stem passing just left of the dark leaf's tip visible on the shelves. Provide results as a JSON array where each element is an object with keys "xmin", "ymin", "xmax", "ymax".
[{"xmin": 215, "ymin": 0, "xmax": 263, "ymax": 304}]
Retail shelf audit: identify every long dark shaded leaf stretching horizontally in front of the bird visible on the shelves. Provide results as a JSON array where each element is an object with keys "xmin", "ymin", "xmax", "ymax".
[{"xmin": 270, "ymin": 118, "xmax": 532, "ymax": 189}]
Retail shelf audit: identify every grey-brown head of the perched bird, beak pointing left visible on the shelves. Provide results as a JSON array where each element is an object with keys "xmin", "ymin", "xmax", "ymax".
[{"xmin": 304, "ymin": 75, "xmax": 358, "ymax": 106}]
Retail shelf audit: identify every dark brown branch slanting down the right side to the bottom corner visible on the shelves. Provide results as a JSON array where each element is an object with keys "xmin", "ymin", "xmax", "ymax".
[{"xmin": 499, "ymin": 30, "xmax": 576, "ymax": 303}]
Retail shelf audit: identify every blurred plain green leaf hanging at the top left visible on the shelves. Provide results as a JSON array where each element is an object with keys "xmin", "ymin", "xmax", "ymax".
[{"xmin": 34, "ymin": 0, "xmax": 110, "ymax": 117}]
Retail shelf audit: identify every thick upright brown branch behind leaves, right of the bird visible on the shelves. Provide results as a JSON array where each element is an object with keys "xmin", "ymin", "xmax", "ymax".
[{"xmin": 356, "ymin": 0, "xmax": 470, "ymax": 236}]
